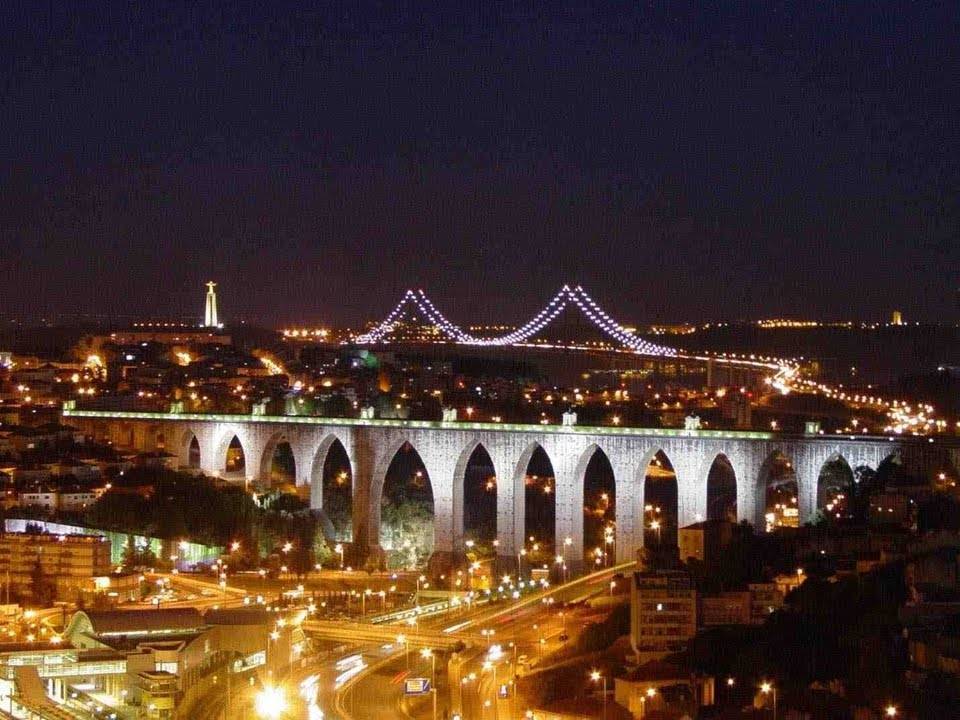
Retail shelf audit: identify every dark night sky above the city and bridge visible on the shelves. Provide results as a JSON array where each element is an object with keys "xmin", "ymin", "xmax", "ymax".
[{"xmin": 0, "ymin": 0, "xmax": 960, "ymax": 323}]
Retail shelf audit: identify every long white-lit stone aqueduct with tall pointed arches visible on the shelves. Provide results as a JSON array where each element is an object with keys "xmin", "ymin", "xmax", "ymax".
[{"xmin": 64, "ymin": 410, "xmax": 960, "ymax": 572}]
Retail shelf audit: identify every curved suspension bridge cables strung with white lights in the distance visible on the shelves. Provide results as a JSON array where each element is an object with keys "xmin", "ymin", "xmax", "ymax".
[{"xmin": 355, "ymin": 285, "xmax": 678, "ymax": 357}]
